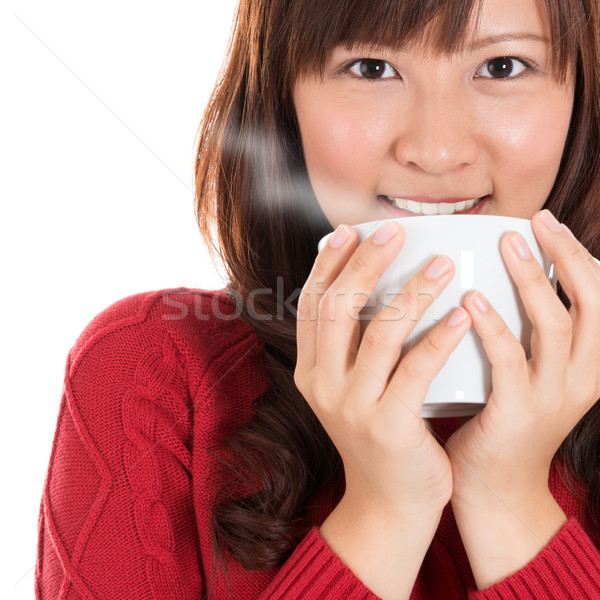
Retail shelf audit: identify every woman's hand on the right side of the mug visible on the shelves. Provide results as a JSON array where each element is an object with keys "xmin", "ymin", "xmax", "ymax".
[{"xmin": 446, "ymin": 210, "xmax": 600, "ymax": 511}]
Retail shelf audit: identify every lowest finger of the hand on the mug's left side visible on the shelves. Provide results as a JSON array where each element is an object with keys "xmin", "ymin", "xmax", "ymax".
[{"xmin": 380, "ymin": 307, "xmax": 471, "ymax": 419}]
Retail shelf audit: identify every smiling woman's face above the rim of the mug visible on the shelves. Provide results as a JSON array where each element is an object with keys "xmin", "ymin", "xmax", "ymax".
[{"xmin": 294, "ymin": 0, "xmax": 574, "ymax": 227}]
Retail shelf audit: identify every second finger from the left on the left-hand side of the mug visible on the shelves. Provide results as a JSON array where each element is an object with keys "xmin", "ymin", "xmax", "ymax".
[{"xmin": 317, "ymin": 221, "xmax": 404, "ymax": 372}]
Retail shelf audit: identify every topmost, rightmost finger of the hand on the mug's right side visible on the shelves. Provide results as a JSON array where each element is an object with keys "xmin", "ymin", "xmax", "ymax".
[{"xmin": 532, "ymin": 210, "xmax": 600, "ymax": 362}]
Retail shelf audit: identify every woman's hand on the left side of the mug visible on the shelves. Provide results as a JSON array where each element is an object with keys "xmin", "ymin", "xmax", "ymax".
[{"xmin": 294, "ymin": 221, "xmax": 471, "ymax": 531}]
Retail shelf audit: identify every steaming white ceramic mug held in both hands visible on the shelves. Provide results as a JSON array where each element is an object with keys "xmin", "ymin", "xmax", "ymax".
[{"xmin": 319, "ymin": 215, "xmax": 556, "ymax": 417}]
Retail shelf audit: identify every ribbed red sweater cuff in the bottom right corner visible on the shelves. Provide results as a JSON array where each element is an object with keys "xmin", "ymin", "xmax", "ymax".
[{"xmin": 469, "ymin": 518, "xmax": 600, "ymax": 600}]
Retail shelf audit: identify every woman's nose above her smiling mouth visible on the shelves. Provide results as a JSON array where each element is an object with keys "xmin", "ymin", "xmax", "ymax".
[{"xmin": 395, "ymin": 87, "xmax": 479, "ymax": 175}]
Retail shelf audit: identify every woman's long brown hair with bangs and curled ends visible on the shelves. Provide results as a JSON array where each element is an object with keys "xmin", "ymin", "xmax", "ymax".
[{"xmin": 195, "ymin": 0, "xmax": 600, "ymax": 570}]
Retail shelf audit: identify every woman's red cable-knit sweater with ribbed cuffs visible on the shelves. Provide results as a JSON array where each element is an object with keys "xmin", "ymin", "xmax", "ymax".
[{"xmin": 36, "ymin": 288, "xmax": 600, "ymax": 600}]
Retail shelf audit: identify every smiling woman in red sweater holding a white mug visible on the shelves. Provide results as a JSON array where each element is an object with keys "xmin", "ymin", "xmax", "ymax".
[{"xmin": 37, "ymin": 0, "xmax": 600, "ymax": 599}]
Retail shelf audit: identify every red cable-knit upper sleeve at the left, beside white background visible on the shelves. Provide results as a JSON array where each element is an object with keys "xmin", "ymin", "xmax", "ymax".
[{"xmin": 35, "ymin": 304, "xmax": 204, "ymax": 600}]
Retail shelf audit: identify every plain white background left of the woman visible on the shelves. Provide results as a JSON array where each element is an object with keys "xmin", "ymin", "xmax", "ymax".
[{"xmin": 0, "ymin": 0, "xmax": 236, "ymax": 599}]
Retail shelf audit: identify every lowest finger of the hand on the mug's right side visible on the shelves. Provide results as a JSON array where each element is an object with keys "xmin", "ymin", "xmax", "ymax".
[{"xmin": 464, "ymin": 292, "xmax": 529, "ymax": 410}]
